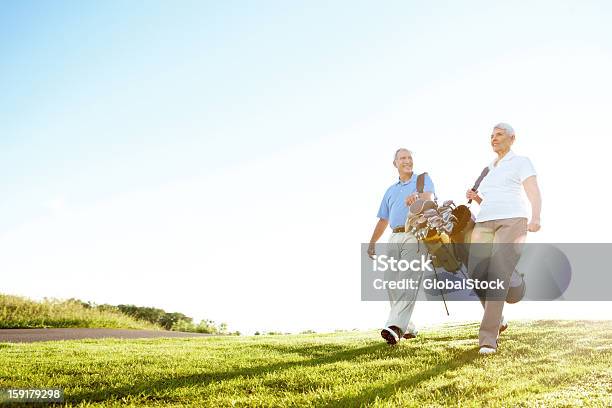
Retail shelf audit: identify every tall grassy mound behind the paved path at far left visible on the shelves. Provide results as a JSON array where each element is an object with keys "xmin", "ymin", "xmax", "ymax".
[{"xmin": 0, "ymin": 294, "xmax": 161, "ymax": 330}]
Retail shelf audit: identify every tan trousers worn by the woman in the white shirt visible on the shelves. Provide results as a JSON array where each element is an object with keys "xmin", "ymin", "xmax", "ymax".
[{"xmin": 468, "ymin": 218, "xmax": 527, "ymax": 348}]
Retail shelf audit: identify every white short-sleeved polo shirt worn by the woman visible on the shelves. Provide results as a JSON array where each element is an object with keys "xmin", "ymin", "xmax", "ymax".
[{"xmin": 476, "ymin": 150, "xmax": 536, "ymax": 222}]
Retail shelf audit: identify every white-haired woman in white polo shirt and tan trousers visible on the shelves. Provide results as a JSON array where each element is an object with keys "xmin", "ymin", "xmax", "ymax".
[{"xmin": 466, "ymin": 123, "xmax": 542, "ymax": 354}]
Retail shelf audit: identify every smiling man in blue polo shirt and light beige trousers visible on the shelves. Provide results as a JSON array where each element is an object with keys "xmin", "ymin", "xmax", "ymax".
[{"xmin": 368, "ymin": 148, "xmax": 435, "ymax": 345}]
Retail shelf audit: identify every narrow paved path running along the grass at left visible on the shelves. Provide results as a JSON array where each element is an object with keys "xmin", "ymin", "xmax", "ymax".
[{"xmin": 0, "ymin": 328, "xmax": 211, "ymax": 343}]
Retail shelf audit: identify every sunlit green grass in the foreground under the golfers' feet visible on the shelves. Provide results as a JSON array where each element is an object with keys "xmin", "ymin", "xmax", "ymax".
[{"xmin": 0, "ymin": 321, "xmax": 612, "ymax": 407}]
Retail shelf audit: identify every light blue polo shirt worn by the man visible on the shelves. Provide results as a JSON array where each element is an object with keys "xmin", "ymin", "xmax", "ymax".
[{"xmin": 377, "ymin": 173, "xmax": 436, "ymax": 228}]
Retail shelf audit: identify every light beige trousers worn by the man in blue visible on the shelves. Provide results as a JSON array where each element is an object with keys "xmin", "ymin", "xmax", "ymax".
[{"xmin": 384, "ymin": 232, "xmax": 423, "ymax": 334}]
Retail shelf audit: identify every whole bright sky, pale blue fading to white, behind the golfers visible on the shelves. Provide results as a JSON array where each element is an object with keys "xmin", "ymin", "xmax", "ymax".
[{"xmin": 0, "ymin": 1, "xmax": 612, "ymax": 332}]
